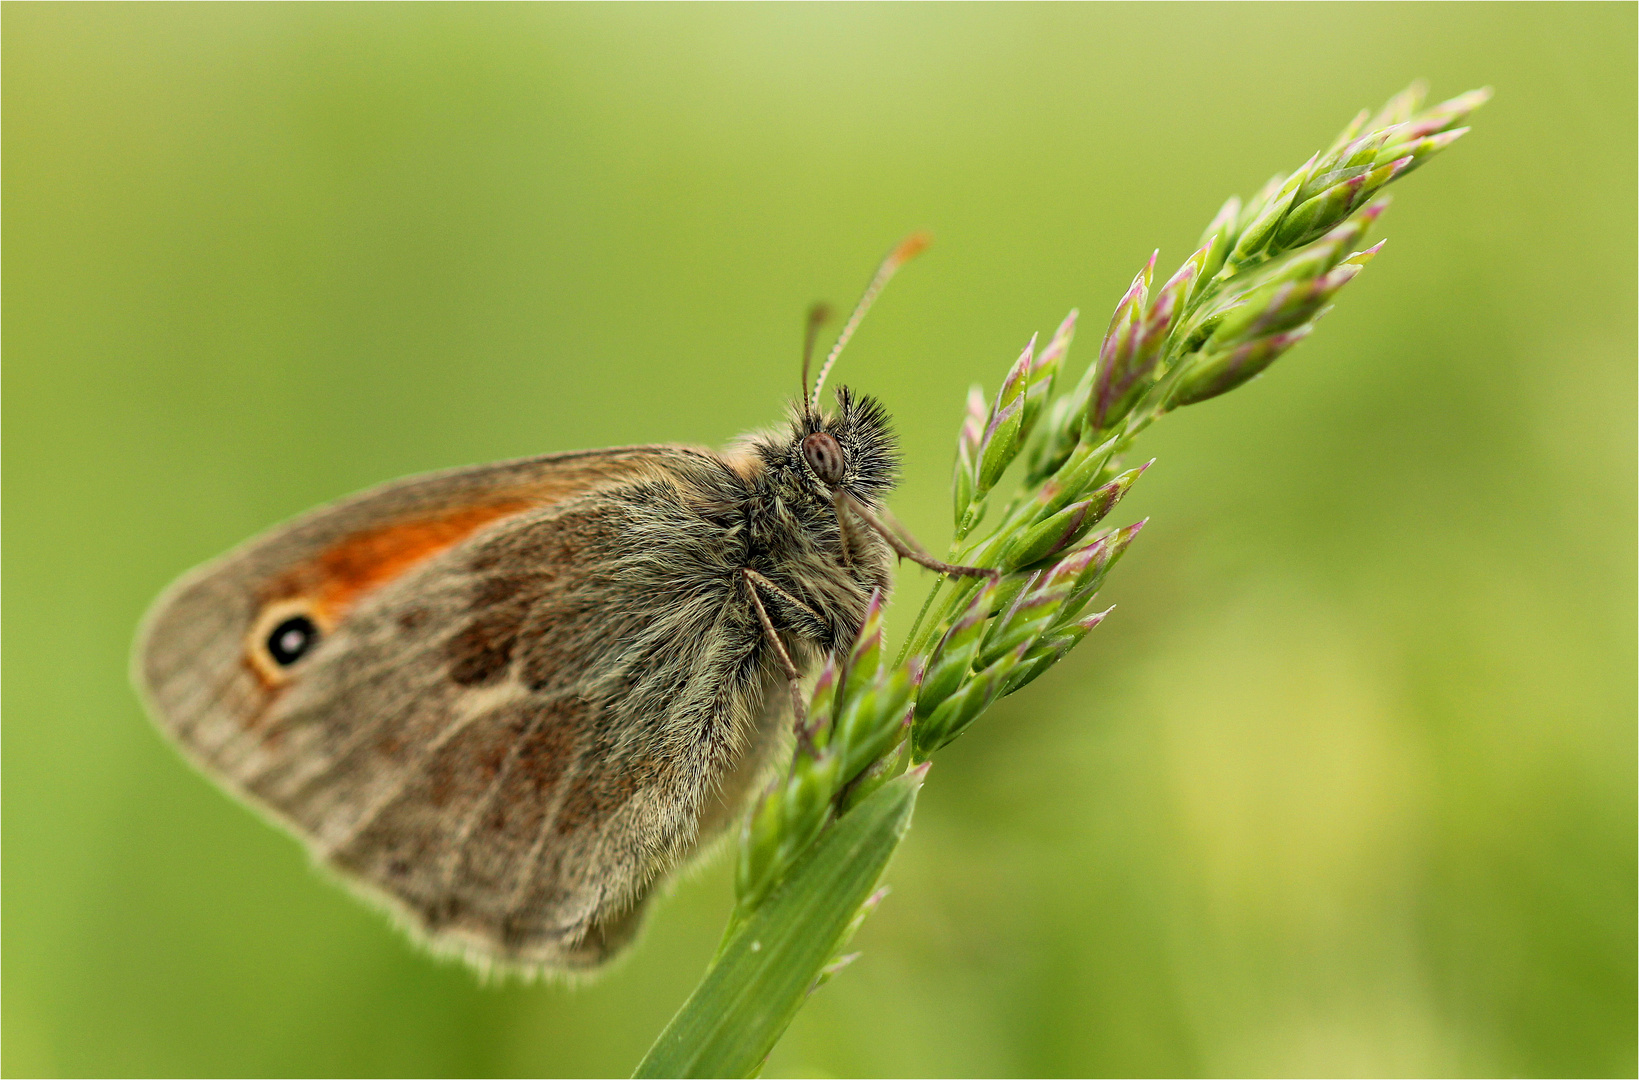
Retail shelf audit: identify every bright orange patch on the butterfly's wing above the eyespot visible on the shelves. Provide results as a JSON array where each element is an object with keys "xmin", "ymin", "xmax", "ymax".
[{"xmin": 269, "ymin": 500, "xmax": 539, "ymax": 626}]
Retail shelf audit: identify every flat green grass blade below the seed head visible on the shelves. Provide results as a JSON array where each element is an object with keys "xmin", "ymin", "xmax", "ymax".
[{"xmin": 633, "ymin": 769, "xmax": 923, "ymax": 1077}]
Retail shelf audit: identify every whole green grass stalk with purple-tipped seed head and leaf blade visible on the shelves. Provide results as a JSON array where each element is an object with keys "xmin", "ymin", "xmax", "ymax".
[{"xmin": 638, "ymin": 85, "xmax": 1490, "ymax": 1077}]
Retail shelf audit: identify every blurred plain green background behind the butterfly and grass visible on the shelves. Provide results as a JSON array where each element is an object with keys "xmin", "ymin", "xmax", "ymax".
[{"xmin": 3, "ymin": 3, "xmax": 1639, "ymax": 1077}]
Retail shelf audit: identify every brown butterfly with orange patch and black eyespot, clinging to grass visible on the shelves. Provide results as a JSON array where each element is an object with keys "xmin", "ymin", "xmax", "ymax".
[{"xmin": 134, "ymin": 236, "xmax": 985, "ymax": 972}]
